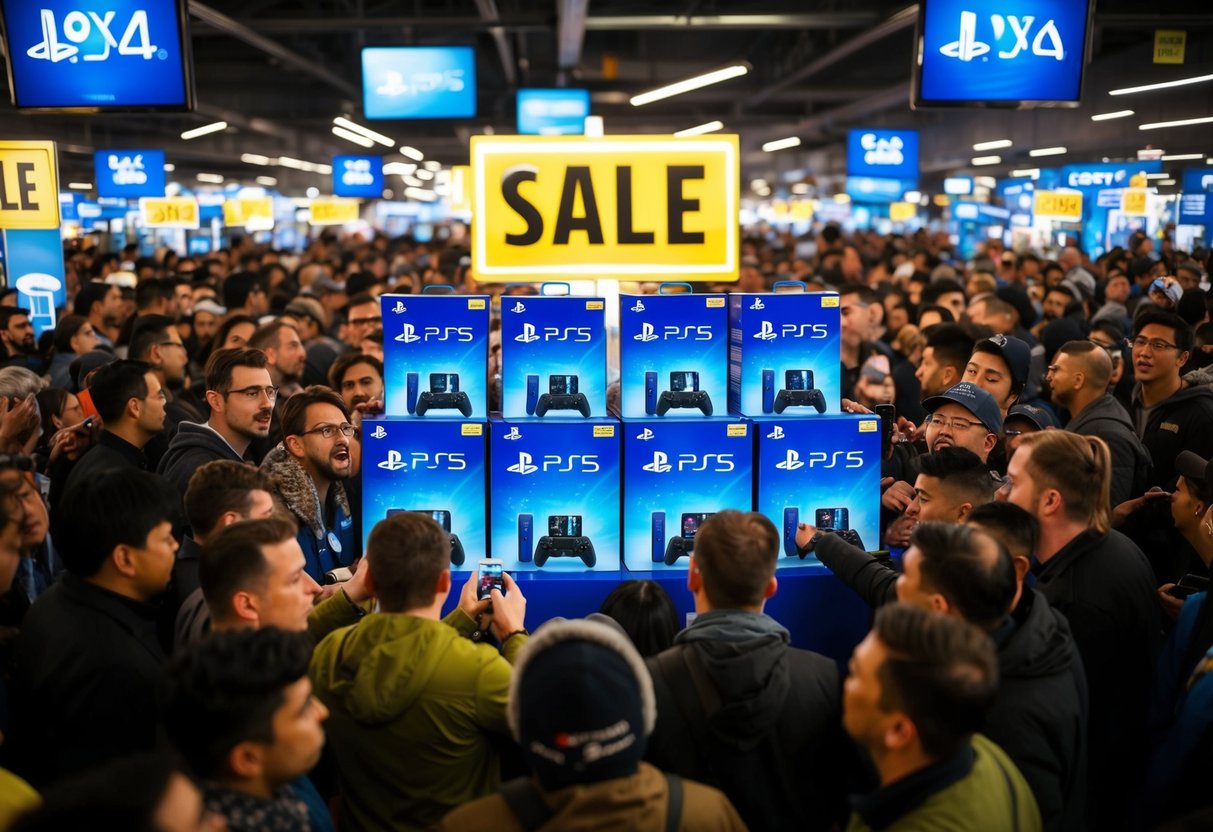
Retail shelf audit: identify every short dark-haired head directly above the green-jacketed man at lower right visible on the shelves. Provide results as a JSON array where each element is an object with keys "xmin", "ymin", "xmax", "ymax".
[{"xmin": 896, "ymin": 523, "xmax": 1019, "ymax": 632}]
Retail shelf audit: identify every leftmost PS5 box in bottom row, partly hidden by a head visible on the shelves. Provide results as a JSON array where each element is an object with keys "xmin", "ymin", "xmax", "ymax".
[{"xmin": 361, "ymin": 418, "xmax": 489, "ymax": 571}]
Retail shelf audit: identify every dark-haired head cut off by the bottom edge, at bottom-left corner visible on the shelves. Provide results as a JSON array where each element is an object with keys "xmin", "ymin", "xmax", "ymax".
[{"xmin": 8, "ymin": 753, "xmax": 227, "ymax": 832}]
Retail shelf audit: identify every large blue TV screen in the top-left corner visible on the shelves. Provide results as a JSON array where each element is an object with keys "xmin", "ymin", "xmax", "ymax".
[{"xmin": 0, "ymin": 0, "xmax": 194, "ymax": 112}]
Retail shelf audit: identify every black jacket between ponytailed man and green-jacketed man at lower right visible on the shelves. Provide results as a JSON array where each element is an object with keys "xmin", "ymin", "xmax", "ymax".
[{"xmin": 981, "ymin": 587, "xmax": 1087, "ymax": 832}]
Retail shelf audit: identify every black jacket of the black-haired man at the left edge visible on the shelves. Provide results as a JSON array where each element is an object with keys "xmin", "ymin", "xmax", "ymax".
[{"xmin": 4, "ymin": 572, "xmax": 165, "ymax": 786}]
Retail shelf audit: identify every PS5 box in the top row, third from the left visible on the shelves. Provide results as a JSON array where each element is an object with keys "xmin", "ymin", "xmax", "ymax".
[{"xmin": 619, "ymin": 294, "xmax": 729, "ymax": 418}]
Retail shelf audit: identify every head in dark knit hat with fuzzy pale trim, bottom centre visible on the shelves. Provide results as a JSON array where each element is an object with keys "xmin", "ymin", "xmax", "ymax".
[{"xmin": 506, "ymin": 620, "xmax": 656, "ymax": 791}]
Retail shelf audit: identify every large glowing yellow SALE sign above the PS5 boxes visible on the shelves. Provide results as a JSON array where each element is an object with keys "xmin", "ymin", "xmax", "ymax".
[{"xmin": 472, "ymin": 136, "xmax": 739, "ymax": 281}]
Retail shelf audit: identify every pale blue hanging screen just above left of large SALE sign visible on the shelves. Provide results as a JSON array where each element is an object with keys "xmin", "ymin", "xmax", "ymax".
[{"xmin": 363, "ymin": 46, "xmax": 475, "ymax": 119}]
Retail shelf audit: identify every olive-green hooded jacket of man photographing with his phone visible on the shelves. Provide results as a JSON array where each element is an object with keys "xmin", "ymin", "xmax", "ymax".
[{"xmin": 309, "ymin": 610, "xmax": 526, "ymax": 832}]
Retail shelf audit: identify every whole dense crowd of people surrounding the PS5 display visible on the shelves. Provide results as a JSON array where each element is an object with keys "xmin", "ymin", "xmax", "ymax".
[{"xmin": 0, "ymin": 226, "xmax": 1213, "ymax": 832}]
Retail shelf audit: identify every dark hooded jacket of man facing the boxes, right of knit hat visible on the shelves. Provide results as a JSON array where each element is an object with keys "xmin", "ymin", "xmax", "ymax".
[{"xmin": 645, "ymin": 610, "xmax": 856, "ymax": 830}]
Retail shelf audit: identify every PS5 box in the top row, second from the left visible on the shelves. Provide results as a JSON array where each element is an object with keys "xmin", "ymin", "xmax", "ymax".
[{"xmin": 501, "ymin": 295, "xmax": 607, "ymax": 420}]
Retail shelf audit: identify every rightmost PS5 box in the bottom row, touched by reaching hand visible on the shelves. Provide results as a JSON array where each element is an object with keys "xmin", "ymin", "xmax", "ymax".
[{"xmin": 753, "ymin": 414, "xmax": 881, "ymax": 569}]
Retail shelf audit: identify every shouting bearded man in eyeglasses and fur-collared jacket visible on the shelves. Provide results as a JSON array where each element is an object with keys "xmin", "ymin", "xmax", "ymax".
[{"xmin": 261, "ymin": 384, "xmax": 360, "ymax": 583}]
